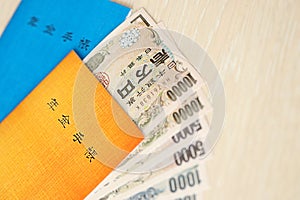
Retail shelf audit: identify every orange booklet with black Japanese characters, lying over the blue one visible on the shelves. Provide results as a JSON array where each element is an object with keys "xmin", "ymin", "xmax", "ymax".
[{"xmin": 0, "ymin": 51, "xmax": 143, "ymax": 199}]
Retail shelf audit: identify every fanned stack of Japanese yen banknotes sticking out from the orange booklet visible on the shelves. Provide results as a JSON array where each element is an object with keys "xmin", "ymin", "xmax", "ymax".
[{"xmin": 84, "ymin": 9, "xmax": 212, "ymax": 200}]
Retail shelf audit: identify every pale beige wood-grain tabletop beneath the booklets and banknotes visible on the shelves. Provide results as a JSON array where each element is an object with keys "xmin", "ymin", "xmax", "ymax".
[{"xmin": 0, "ymin": 0, "xmax": 300, "ymax": 200}]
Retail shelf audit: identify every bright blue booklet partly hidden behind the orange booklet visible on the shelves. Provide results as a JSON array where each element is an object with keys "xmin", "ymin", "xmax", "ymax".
[{"xmin": 0, "ymin": 0, "xmax": 129, "ymax": 122}]
